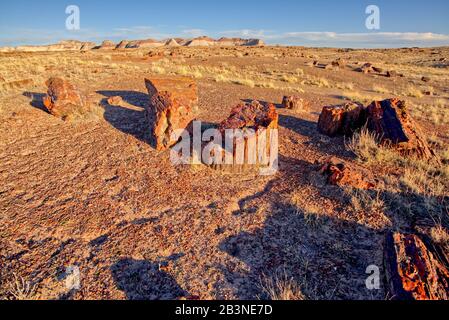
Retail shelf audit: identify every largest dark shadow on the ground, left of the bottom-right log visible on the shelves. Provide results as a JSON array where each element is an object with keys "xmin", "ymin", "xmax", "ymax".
[{"xmin": 219, "ymin": 202, "xmax": 384, "ymax": 300}]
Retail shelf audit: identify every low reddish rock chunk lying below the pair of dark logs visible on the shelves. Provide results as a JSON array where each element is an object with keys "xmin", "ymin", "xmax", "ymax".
[{"xmin": 319, "ymin": 157, "xmax": 375, "ymax": 190}]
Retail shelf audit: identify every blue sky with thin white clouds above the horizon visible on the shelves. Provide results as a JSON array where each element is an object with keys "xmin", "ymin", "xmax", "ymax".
[{"xmin": 0, "ymin": 0, "xmax": 449, "ymax": 47}]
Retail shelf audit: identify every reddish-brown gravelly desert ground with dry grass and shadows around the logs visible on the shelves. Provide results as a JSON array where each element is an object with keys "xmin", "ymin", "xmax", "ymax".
[{"xmin": 0, "ymin": 46, "xmax": 449, "ymax": 300}]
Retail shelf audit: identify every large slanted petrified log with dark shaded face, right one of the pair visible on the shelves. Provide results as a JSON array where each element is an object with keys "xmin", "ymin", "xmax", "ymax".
[{"xmin": 366, "ymin": 99, "xmax": 435, "ymax": 159}]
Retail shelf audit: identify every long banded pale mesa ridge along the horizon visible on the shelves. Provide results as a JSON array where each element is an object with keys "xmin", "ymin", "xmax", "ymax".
[{"xmin": 0, "ymin": 36, "xmax": 265, "ymax": 52}]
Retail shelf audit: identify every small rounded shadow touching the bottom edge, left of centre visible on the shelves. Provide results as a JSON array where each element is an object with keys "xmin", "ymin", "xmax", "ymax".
[{"xmin": 111, "ymin": 258, "xmax": 187, "ymax": 300}]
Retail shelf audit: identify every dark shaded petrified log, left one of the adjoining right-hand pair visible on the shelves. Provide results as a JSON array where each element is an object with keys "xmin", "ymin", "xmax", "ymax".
[{"xmin": 318, "ymin": 102, "xmax": 366, "ymax": 137}]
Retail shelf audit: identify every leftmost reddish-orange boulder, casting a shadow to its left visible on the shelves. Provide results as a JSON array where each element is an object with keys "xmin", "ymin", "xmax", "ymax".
[{"xmin": 43, "ymin": 78, "xmax": 87, "ymax": 119}]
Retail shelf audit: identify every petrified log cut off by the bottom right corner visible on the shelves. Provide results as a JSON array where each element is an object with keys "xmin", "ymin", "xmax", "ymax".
[{"xmin": 384, "ymin": 233, "xmax": 449, "ymax": 300}]
